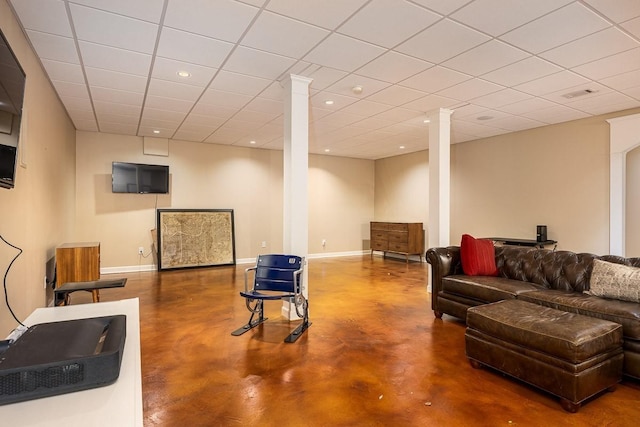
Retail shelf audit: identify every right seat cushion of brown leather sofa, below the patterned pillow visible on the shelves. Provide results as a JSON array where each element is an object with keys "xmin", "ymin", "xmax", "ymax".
[{"xmin": 518, "ymin": 290, "xmax": 640, "ymax": 340}]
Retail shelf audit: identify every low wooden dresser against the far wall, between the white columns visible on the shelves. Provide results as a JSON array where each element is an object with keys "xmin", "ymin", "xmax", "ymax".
[{"xmin": 371, "ymin": 221, "xmax": 424, "ymax": 262}]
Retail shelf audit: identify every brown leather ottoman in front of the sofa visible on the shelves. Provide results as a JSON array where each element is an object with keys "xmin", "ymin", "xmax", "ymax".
[{"xmin": 465, "ymin": 300, "xmax": 623, "ymax": 412}]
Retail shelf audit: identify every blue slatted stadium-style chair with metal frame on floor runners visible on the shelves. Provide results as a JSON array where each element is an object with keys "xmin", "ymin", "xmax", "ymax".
[{"xmin": 231, "ymin": 255, "xmax": 311, "ymax": 343}]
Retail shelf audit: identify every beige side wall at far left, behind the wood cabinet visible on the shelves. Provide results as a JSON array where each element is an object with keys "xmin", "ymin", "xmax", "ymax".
[{"xmin": 0, "ymin": 0, "xmax": 75, "ymax": 337}]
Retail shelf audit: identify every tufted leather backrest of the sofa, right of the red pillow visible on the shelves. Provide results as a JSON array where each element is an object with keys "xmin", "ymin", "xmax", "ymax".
[{"xmin": 496, "ymin": 246, "xmax": 640, "ymax": 292}]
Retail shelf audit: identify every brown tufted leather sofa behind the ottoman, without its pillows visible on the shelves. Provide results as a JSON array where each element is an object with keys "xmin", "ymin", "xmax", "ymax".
[{"xmin": 426, "ymin": 246, "xmax": 640, "ymax": 379}]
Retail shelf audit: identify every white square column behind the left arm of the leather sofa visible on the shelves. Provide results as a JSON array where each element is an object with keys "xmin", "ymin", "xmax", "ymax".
[{"xmin": 427, "ymin": 108, "xmax": 453, "ymax": 248}]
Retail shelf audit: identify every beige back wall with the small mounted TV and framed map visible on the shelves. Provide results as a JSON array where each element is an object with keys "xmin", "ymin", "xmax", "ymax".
[{"xmin": 75, "ymin": 131, "xmax": 374, "ymax": 271}]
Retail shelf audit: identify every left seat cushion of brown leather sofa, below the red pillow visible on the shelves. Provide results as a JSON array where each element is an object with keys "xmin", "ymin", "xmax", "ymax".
[{"xmin": 442, "ymin": 275, "xmax": 543, "ymax": 303}]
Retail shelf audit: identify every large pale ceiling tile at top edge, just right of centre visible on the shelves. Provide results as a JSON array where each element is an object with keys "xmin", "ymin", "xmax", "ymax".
[{"xmin": 338, "ymin": 0, "xmax": 441, "ymax": 48}]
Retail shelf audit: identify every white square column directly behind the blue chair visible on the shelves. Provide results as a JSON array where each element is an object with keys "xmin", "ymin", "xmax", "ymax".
[{"xmin": 282, "ymin": 74, "xmax": 312, "ymax": 320}]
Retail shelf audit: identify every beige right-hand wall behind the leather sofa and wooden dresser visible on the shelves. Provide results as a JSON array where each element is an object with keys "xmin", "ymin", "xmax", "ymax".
[{"xmin": 375, "ymin": 110, "xmax": 640, "ymax": 256}]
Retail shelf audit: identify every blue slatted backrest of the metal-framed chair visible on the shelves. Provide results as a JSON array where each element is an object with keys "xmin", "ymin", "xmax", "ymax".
[{"xmin": 254, "ymin": 255, "xmax": 303, "ymax": 292}]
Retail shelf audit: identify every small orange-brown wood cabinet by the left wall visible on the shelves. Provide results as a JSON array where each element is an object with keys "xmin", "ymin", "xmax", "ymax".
[{"xmin": 56, "ymin": 242, "xmax": 100, "ymax": 300}]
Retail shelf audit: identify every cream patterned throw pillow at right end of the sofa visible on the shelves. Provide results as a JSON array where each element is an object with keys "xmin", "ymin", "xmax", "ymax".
[{"xmin": 585, "ymin": 259, "xmax": 640, "ymax": 302}]
